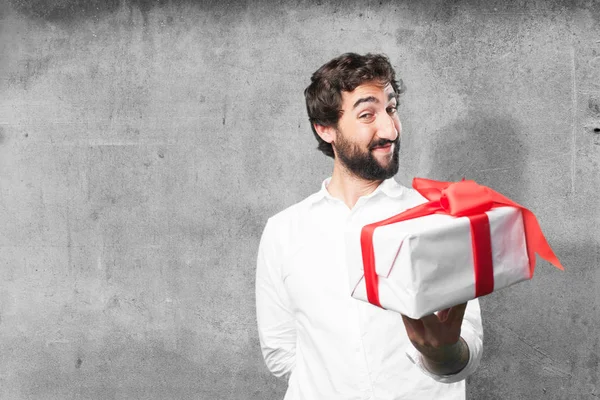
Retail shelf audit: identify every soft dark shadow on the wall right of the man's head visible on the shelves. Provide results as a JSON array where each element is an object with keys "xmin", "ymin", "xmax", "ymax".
[{"xmin": 423, "ymin": 111, "xmax": 527, "ymax": 197}]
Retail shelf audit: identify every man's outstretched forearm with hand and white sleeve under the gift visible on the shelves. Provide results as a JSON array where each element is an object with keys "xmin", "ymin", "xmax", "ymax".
[{"xmin": 402, "ymin": 299, "xmax": 483, "ymax": 383}]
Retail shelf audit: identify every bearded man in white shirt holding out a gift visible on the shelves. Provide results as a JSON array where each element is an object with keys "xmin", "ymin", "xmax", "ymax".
[{"xmin": 256, "ymin": 53, "xmax": 483, "ymax": 400}]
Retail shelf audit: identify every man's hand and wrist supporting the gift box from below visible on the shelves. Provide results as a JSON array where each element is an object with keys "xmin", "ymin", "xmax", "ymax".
[{"xmin": 402, "ymin": 303, "xmax": 469, "ymax": 375}]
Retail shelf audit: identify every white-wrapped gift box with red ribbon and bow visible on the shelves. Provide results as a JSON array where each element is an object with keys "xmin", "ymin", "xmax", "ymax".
[{"xmin": 347, "ymin": 178, "xmax": 563, "ymax": 319}]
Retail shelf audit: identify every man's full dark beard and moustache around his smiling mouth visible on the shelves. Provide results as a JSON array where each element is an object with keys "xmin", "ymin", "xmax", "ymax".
[{"xmin": 335, "ymin": 130, "xmax": 400, "ymax": 181}]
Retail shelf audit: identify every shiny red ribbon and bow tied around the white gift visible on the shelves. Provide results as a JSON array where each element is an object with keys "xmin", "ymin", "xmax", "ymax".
[{"xmin": 360, "ymin": 178, "xmax": 564, "ymax": 307}]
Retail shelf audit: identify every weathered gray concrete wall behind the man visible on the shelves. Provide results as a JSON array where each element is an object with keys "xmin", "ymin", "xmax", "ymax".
[{"xmin": 0, "ymin": 0, "xmax": 600, "ymax": 400}]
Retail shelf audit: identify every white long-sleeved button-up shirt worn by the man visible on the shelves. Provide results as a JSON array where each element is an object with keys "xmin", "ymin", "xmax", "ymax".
[{"xmin": 256, "ymin": 179, "xmax": 483, "ymax": 400}]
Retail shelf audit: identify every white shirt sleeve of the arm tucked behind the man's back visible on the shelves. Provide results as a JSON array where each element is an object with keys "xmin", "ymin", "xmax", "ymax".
[{"xmin": 256, "ymin": 220, "xmax": 296, "ymax": 377}]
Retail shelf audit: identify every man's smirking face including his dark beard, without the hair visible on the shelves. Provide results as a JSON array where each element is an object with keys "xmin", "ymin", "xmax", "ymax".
[{"xmin": 332, "ymin": 82, "xmax": 402, "ymax": 180}]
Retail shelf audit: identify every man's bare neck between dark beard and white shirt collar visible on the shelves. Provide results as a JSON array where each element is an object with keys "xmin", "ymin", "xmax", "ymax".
[{"xmin": 327, "ymin": 162, "xmax": 382, "ymax": 209}]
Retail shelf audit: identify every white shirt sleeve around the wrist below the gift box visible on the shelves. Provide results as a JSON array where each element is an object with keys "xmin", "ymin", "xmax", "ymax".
[{"xmin": 406, "ymin": 299, "xmax": 483, "ymax": 383}]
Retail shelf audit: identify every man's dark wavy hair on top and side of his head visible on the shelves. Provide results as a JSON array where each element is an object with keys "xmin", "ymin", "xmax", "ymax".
[{"xmin": 304, "ymin": 53, "xmax": 402, "ymax": 158}]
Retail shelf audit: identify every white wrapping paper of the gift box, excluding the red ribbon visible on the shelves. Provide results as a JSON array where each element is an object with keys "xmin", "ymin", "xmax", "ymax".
[{"xmin": 346, "ymin": 207, "xmax": 531, "ymax": 319}]
